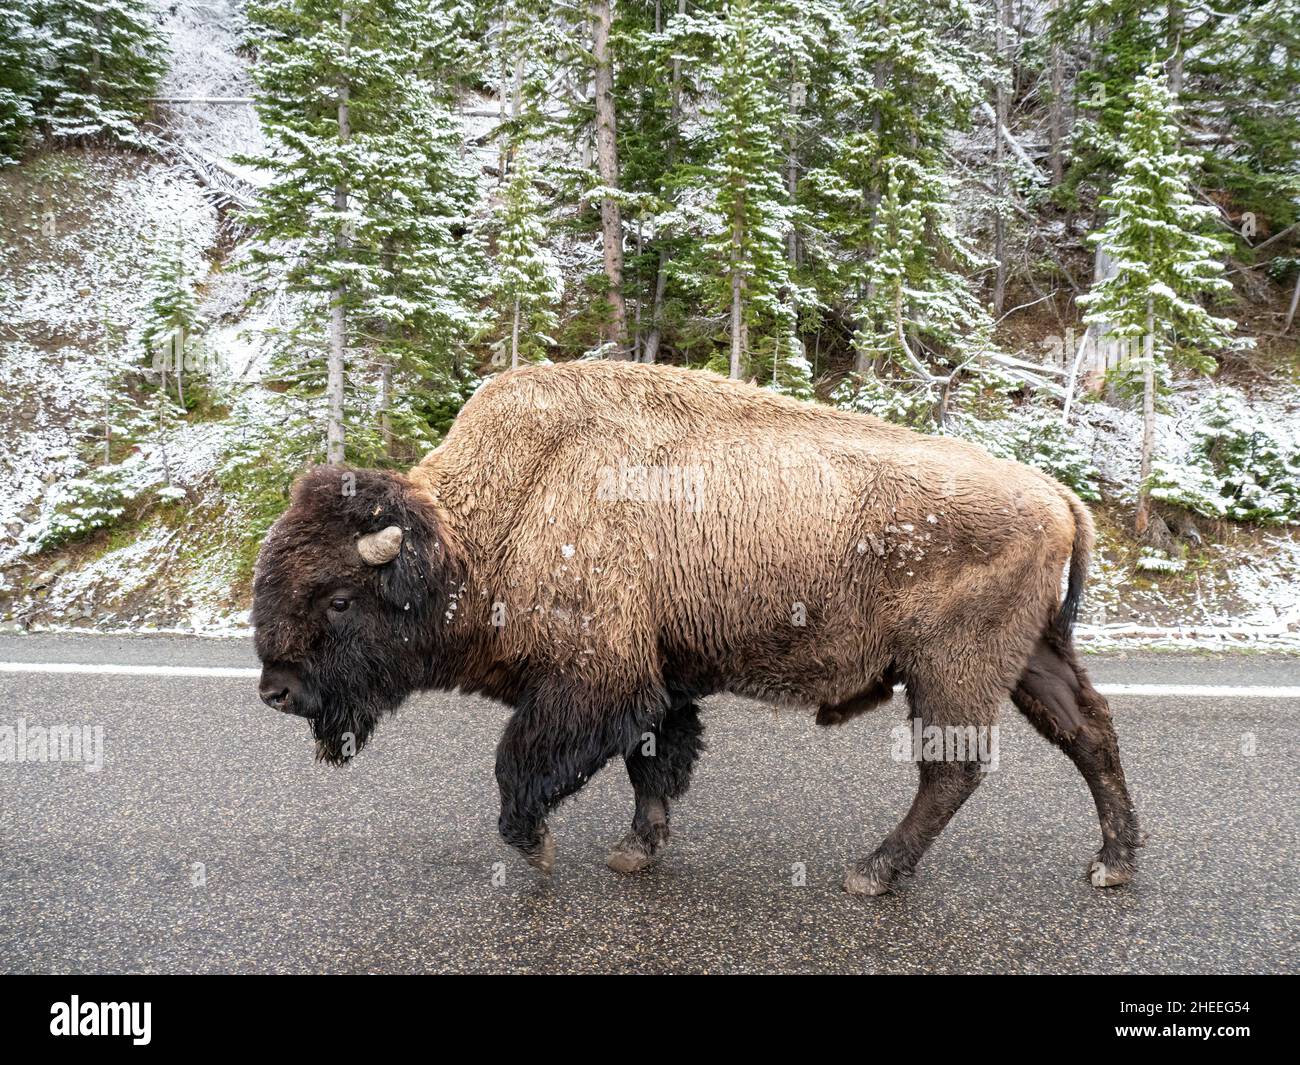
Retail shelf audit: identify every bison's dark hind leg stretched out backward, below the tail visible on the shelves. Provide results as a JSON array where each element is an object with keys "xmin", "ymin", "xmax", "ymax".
[{"xmin": 1011, "ymin": 636, "xmax": 1140, "ymax": 887}]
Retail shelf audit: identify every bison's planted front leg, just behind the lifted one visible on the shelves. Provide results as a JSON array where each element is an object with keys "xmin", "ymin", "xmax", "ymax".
[{"xmin": 608, "ymin": 701, "xmax": 703, "ymax": 873}]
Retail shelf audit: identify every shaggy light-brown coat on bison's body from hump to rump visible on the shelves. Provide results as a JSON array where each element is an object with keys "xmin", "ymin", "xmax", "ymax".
[{"xmin": 410, "ymin": 362, "xmax": 1076, "ymax": 723}]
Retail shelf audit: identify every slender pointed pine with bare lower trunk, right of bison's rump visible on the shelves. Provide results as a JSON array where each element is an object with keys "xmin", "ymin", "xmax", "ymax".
[{"xmin": 1080, "ymin": 64, "xmax": 1242, "ymax": 534}]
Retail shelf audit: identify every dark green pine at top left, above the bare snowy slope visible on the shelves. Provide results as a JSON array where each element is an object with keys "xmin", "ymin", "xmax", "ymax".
[{"xmin": 30, "ymin": 0, "xmax": 166, "ymax": 146}]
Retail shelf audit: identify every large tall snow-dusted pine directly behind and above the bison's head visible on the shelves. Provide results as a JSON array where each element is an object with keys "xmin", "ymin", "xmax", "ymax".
[{"xmin": 241, "ymin": 0, "xmax": 478, "ymax": 463}]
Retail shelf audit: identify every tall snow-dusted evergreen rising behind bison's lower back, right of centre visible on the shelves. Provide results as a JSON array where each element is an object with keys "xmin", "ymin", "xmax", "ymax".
[{"xmin": 801, "ymin": 0, "xmax": 992, "ymax": 380}]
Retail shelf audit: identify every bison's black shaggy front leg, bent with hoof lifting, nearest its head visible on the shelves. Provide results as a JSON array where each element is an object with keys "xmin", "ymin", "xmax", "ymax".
[{"xmin": 497, "ymin": 698, "xmax": 620, "ymax": 873}]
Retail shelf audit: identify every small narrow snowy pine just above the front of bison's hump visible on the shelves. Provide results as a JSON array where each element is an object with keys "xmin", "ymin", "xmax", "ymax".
[{"xmin": 494, "ymin": 152, "xmax": 564, "ymax": 368}]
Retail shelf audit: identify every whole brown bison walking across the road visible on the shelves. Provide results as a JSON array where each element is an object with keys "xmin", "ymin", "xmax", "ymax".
[{"xmin": 252, "ymin": 362, "xmax": 1139, "ymax": 895}]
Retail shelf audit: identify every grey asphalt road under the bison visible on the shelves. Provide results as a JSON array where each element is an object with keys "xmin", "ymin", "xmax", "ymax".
[{"xmin": 0, "ymin": 636, "xmax": 1300, "ymax": 973}]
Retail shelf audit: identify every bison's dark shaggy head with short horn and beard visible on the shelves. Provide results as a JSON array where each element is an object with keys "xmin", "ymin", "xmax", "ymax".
[{"xmin": 252, "ymin": 467, "xmax": 454, "ymax": 765}]
